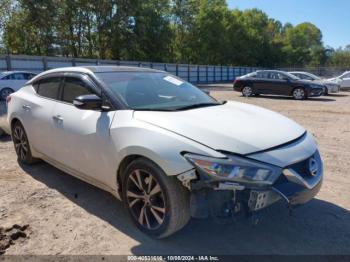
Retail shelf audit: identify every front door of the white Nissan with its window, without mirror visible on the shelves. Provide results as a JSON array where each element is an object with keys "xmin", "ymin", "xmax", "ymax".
[{"xmin": 52, "ymin": 74, "xmax": 115, "ymax": 183}]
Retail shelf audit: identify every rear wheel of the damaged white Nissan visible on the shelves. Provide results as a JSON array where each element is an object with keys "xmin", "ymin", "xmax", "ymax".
[{"xmin": 12, "ymin": 121, "xmax": 38, "ymax": 165}]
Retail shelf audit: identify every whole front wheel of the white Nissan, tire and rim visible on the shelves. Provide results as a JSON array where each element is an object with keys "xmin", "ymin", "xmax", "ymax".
[{"xmin": 122, "ymin": 158, "xmax": 190, "ymax": 239}]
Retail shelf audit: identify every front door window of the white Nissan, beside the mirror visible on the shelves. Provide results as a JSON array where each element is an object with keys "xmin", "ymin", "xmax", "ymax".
[{"xmin": 62, "ymin": 77, "xmax": 93, "ymax": 103}]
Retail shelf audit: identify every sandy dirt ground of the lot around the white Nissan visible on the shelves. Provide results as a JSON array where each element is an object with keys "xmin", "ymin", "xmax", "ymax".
[{"xmin": 0, "ymin": 86, "xmax": 350, "ymax": 255}]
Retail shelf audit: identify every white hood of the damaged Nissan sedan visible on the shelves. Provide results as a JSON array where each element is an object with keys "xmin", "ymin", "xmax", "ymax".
[{"xmin": 134, "ymin": 102, "xmax": 305, "ymax": 154}]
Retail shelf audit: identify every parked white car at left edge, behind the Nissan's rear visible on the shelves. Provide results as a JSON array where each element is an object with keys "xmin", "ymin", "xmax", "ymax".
[{"xmin": 0, "ymin": 71, "xmax": 36, "ymax": 100}]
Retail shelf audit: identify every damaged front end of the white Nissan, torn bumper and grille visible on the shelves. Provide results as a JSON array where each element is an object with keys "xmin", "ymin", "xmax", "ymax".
[{"xmin": 183, "ymin": 151, "xmax": 323, "ymax": 218}]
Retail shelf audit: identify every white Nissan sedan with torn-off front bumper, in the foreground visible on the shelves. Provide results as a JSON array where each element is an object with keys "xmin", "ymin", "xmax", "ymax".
[{"xmin": 7, "ymin": 66, "xmax": 323, "ymax": 238}]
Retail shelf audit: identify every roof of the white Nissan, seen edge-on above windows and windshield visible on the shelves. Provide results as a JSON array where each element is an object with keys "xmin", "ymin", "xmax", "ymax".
[{"xmin": 30, "ymin": 66, "xmax": 164, "ymax": 82}]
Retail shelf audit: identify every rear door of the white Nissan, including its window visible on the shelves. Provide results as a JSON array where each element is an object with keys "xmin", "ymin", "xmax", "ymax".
[{"xmin": 21, "ymin": 76, "xmax": 62, "ymax": 158}]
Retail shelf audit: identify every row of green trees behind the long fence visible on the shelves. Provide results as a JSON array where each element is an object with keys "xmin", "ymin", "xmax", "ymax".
[{"xmin": 0, "ymin": 0, "xmax": 350, "ymax": 67}]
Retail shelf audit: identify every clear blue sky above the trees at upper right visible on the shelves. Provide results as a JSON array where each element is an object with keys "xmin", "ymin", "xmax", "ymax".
[{"xmin": 227, "ymin": 0, "xmax": 350, "ymax": 48}]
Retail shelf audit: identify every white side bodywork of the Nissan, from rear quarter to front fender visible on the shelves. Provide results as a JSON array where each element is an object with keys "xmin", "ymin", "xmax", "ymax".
[{"xmin": 7, "ymin": 85, "xmax": 225, "ymax": 196}]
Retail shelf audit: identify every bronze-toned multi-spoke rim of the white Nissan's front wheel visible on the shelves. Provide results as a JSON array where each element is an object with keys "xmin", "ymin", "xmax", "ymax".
[{"xmin": 126, "ymin": 169, "xmax": 165, "ymax": 230}]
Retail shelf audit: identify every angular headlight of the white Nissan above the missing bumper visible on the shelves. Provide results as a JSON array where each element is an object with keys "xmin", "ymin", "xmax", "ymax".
[{"xmin": 184, "ymin": 153, "xmax": 282, "ymax": 185}]
